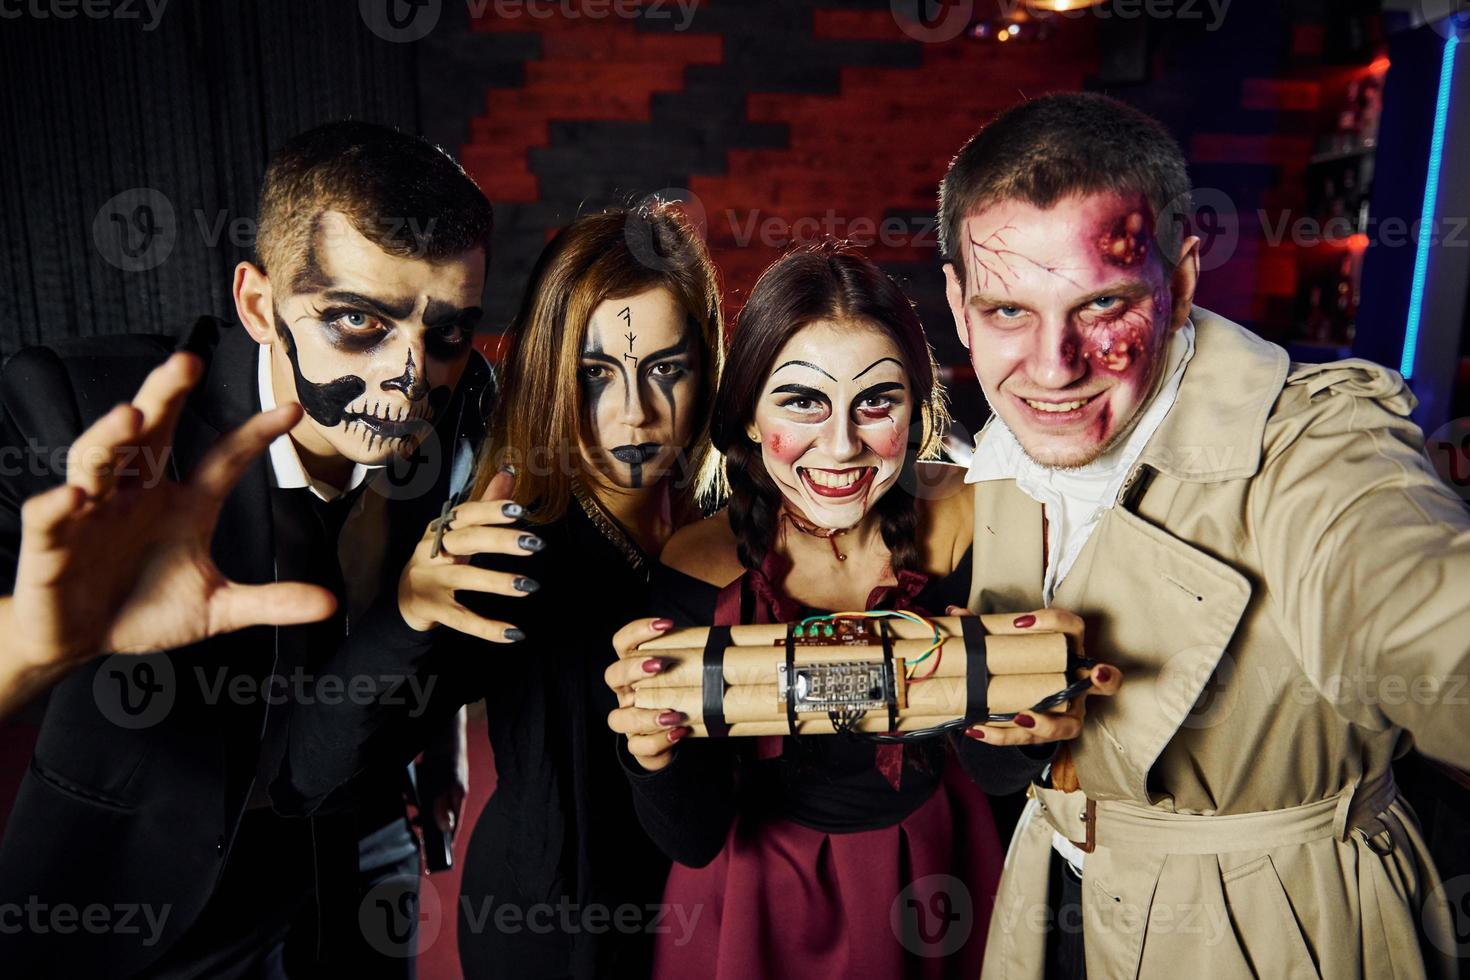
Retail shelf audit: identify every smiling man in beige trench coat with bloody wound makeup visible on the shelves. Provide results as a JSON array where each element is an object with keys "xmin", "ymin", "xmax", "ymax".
[{"xmin": 939, "ymin": 94, "xmax": 1470, "ymax": 977}]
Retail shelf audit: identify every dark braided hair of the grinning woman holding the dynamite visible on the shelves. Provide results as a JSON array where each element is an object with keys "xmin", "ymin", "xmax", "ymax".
[{"xmin": 710, "ymin": 242, "xmax": 948, "ymax": 573}]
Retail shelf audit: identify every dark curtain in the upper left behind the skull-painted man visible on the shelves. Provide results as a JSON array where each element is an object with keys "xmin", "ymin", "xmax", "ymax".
[{"xmin": 0, "ymin": 0, "xmax": 417, "ymax": 356}]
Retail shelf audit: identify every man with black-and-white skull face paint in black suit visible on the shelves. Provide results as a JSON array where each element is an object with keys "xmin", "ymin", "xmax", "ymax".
[{"xmin": 0, "ymin": 122, "xmax": 525, "ymax": 977}]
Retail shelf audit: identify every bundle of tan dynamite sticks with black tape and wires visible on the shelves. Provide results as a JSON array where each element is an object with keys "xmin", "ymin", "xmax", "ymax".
[{"xmin": 634, "ymin": 614, "xmax": 1073, "ymax": 738}]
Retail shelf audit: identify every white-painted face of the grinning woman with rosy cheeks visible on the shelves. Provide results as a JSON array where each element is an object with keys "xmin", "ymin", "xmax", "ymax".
[{"xmin": 747, "ymin": 320, "xmax": 914, "ymax": 532}]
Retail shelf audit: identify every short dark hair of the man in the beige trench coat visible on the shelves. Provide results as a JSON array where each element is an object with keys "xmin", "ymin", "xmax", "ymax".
[{"xmin": 939, "ymin": 93, "xmax": 1189, "ymax": 284}]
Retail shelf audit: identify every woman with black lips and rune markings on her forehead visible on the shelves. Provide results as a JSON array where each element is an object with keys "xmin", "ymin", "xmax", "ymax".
[{"xmin": 431, "ymin": 204, "xmax": 722, "ymax": 977}]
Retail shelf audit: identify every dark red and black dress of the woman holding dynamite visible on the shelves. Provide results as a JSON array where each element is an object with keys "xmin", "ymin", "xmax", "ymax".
[{"xmin": 625, "ymin": 557, "xmax": 1044, "ymax": 980}]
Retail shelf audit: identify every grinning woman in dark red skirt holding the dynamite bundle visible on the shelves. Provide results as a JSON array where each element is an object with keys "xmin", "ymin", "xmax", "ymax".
[{"xmin": 606, "ymin": 247, "xmax": 1117, "ymax": 977}]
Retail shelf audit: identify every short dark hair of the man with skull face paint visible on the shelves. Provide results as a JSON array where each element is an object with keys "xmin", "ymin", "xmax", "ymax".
[{"xmin": 256, "ymin": 119, "xmax": 494, "ymax": 288}]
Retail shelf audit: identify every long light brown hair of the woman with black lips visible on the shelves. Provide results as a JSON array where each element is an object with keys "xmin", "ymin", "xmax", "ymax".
[{"xmin": 475, "ymin": 201, "xmax": 723, "ymax": 523}]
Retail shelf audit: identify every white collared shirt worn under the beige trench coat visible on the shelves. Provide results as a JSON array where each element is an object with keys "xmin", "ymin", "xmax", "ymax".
[{"xmin": 964, "ymin": 322, "xmax": 1195, "ymax": 874}]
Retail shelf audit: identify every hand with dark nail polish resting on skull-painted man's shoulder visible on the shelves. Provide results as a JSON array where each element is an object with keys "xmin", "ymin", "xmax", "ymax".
[{"xmin": 398, "ymin": 472, "xmax": 545, "ymax": 644}]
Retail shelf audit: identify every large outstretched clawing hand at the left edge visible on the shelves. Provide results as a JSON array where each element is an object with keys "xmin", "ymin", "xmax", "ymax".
[{"xmin": 0, "ymin": 353, "xmax": 335, "ymax": 681}]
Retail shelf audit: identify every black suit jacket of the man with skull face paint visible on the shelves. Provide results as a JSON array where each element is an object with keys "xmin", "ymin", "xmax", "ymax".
[{"xmin": 0, "ymin": 317, "xmax": 492, "ymax": 977}]
